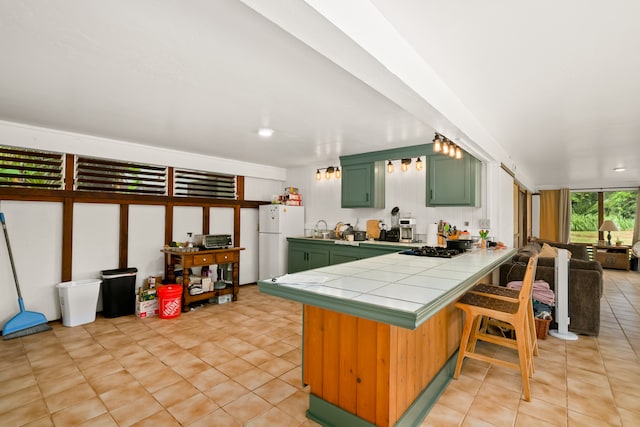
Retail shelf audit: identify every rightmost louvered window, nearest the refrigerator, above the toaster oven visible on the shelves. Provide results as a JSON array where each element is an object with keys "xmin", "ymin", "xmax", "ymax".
[{"xmin": 174, "ymin": 169, "xmax": 236, "ymax": 200}]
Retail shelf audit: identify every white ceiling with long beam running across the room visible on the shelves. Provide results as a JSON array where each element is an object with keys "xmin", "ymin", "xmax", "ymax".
[{"xmin": 0, "ymin": 0, "xmax": 640, "ymax": 190}]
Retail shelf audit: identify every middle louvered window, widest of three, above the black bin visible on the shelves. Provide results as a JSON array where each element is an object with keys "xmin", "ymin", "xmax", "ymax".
[{"xmin": 75, "ymin": 156, "xmax": 167, "ymax": 196}]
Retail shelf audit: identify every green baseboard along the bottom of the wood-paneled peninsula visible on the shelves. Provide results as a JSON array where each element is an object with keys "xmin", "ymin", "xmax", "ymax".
[{"xmin": 307, "ymin": 351, "xmax": 458, "ymax": 427}]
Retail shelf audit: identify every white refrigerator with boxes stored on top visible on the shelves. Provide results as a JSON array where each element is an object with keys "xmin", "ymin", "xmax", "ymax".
[{"xmin": 258, "ymin": 205, "xmax": 304, "ymax": 279}]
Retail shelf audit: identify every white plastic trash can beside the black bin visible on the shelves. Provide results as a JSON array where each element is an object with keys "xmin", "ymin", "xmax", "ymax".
[{"xmin": 56, "ymin": 279, "xmax": 102, "ymax": 326}]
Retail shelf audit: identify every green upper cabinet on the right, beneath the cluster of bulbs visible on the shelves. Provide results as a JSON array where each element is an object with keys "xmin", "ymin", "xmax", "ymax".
[{"xmin": 426, "ymin": 154, "xmax": 481, "ymax": 206}]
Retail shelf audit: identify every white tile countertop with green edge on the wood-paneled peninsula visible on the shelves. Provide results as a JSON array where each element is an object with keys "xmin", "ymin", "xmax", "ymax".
[{"xmin": 258, "ymin": 248, "xmax": 516, "ymax": 329}]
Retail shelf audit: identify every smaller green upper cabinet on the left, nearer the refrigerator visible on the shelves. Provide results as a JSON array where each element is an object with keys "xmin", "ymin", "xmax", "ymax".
[{"xmin": 342, "ymin": 161, "xmax": 385, "ymax": 208}]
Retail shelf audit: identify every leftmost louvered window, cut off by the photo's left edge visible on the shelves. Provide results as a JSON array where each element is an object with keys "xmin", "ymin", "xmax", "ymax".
[{"xmin": 0, "ymin": 145, "xmax": 64, "ymax": 190}]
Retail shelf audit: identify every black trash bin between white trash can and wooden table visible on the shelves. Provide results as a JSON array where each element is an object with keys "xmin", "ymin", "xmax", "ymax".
[{"xmin": 100, "ymin": 268, "xmax": 138, "ymax": 317}]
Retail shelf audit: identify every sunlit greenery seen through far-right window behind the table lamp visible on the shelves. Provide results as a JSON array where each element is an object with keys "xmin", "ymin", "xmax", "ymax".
[{"xmin": 570, "ymin": 191, "xmax": 637, "ymax": 245}]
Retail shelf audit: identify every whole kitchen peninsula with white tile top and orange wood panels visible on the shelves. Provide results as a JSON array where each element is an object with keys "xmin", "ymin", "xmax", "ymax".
[{"xmin": 258, "ymin": 249, "xmax": 515, "ymax": 427}]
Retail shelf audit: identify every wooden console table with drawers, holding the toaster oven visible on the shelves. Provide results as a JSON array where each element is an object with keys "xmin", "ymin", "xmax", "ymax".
[{"xmin": 162, "ymin": 248, "xmax": 244, "ymax": 312}]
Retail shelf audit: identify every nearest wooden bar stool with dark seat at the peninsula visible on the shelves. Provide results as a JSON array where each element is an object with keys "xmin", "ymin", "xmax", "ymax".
[{"xmin": 453, "ymin": 257, "xmax": 538, "ymax": 401}]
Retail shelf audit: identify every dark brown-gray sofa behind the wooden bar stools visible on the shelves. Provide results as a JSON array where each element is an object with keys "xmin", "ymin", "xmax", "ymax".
[{"xmin": 500, "ymin": 240, "xmax": 603, "ymax": 335}]
